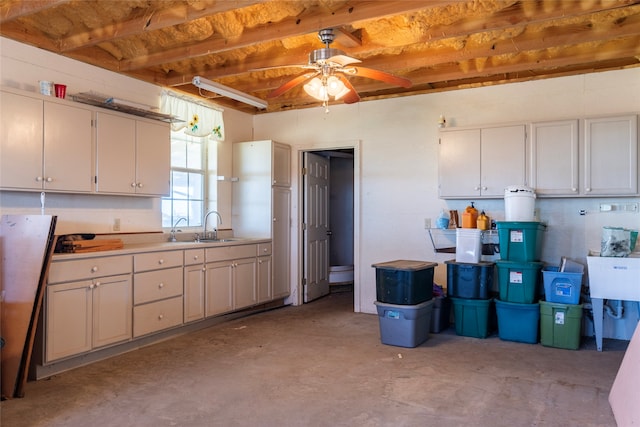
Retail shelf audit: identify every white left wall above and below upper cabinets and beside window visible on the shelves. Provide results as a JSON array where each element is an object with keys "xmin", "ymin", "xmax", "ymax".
[{"xmin": 0, "ymin": 37, "xmax": 253, "ymax": 234}]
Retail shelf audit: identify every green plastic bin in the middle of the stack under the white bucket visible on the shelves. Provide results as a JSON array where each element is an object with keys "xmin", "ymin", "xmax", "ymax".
[{"xmin": 496, "ymin": 260, "xmax": 543, "ymax": 304}]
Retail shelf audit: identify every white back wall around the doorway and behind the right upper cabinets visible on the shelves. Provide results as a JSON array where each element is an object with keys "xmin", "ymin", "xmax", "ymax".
[{"xmin": 254, "ymin": 68, "xmax": 640, "ymax": 338}]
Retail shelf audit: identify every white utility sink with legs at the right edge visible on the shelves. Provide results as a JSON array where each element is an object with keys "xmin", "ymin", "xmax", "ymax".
[{"xmin": 587, "ymin": 253, "xmax": 640, "ymax": 351}]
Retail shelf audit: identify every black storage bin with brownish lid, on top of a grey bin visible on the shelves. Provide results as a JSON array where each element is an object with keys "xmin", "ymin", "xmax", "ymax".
[{"xmin": 372, "ymin": 260, "xmax": 438, "ymax": 305}]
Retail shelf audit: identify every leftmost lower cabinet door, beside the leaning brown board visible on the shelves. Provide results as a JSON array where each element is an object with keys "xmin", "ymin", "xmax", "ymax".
[{"xmin": 45, "ymin": 280, "xmax": 93, "ymax": 362}]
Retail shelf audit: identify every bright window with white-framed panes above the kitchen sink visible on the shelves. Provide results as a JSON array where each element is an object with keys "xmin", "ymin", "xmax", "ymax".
[{"xmin": 162, "ymin": 131, "xmax": 217, "ymax": 228}]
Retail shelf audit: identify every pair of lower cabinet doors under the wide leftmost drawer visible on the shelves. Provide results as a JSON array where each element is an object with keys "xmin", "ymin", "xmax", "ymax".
[{"xmin": 45, "ymin": 274, "xmax": 131, "ymax": 362}]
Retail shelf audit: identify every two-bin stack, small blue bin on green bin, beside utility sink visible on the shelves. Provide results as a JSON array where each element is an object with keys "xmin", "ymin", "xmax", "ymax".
[{"xmin": 540, "ymin": 262, "xmax": 584, "ymax": 350}]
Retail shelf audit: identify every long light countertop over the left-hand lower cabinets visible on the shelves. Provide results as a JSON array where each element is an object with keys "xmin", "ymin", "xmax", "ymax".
[{"xmin": 53, "ymin": 237, "xmax": 271, "ymax": 261}]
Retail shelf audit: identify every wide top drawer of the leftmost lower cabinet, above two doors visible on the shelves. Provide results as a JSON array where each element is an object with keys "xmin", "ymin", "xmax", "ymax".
[{"xmin": 49, "ymin": 255, "xmax": 131, "ymax": 283}]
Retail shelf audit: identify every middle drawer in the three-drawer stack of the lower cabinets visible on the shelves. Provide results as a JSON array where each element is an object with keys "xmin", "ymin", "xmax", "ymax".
[{"xmin": 133, "ymin": 267, "xmax": 182, "ymax": 304}]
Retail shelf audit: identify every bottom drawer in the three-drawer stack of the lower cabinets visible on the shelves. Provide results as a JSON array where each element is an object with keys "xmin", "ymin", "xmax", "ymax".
[{"xmin": 133, "ymin": 297, "xmax": 182, "ymax": 337}]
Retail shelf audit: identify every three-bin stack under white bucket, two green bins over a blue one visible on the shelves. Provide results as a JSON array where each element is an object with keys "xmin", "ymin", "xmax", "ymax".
[{"xmin": 495, "ymin": 221, "xmax": 546, "ymax": 344}]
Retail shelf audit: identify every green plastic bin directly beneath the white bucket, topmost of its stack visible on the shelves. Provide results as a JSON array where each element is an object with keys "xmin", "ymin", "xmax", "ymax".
[{"xmin": 496, "ymin": 221, "xmax": 546, "ymax": 262}]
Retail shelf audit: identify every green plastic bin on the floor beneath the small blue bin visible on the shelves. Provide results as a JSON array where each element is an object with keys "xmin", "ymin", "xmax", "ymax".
[{"xmin": 540, "ymin": 301, "xmax": 582, "ymax": 350}]
